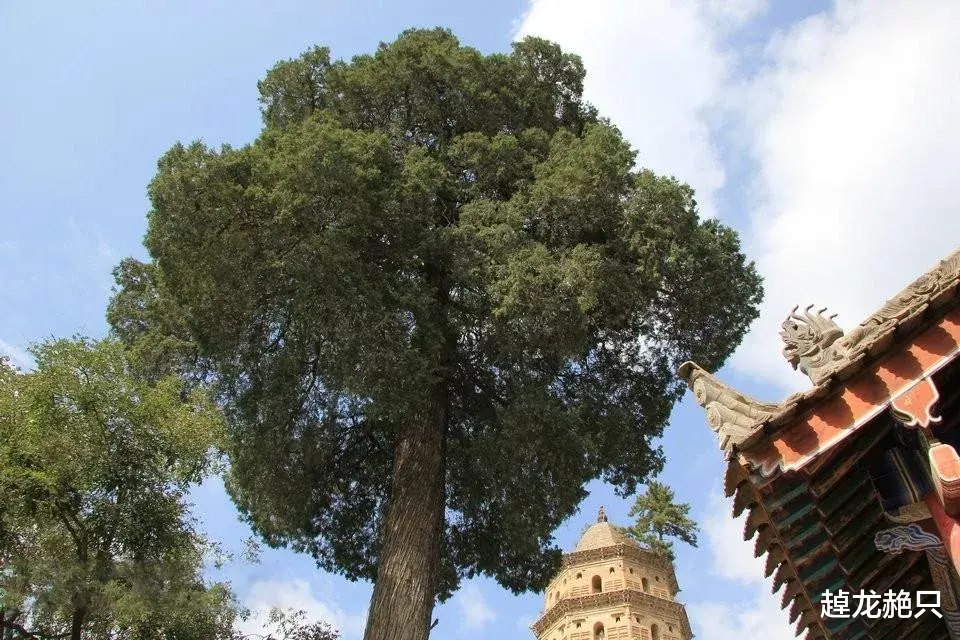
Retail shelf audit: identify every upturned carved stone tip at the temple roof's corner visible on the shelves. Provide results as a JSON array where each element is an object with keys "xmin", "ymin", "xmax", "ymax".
[{"xmin": 679, "ymin": 362, "xmax": 780, "ymax": 456}]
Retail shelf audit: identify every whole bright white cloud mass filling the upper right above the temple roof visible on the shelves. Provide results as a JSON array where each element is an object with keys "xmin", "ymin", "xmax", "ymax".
[{"xmin": 517, "ymin": 0, "xmax": 960, "ymax": 391}]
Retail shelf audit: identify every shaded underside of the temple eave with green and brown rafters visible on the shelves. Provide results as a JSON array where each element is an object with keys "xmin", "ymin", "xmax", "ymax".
[{"xmin": 724, "ymin": 423, "xmax": 946, "ymax": 640}]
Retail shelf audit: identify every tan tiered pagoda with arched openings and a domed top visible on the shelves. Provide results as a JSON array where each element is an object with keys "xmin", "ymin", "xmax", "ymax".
[{"xmin": 531, "ymin": 507, "xmax": 693, "ymax": 640}]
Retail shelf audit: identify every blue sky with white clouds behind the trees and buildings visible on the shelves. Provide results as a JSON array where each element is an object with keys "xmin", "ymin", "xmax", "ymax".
[{"xmin": 0, "ymin": 0, "xmax": 960, "ymax": 640}]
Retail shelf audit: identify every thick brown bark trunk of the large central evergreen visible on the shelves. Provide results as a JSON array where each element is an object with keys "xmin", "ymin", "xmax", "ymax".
[{"xmin": 363, "ymin": 393, "xmax": 447, "ymax": 640}]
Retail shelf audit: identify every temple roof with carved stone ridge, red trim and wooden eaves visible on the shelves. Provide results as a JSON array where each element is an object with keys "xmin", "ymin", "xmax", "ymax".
[{"xmin": 679, "ymin": 250, "xmax": 960, "ymax": 640}]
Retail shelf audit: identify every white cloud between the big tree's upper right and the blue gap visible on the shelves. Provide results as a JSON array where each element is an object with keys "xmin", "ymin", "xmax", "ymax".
[{"xmin": 517, "ymin": 0, "xmax": 765, "ymax": 216}]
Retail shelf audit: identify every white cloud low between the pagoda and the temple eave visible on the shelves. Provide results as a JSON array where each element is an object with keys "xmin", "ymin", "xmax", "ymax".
[{"xmin": 687, "ymin": 490, "xmax": 794, "ymax": 640}]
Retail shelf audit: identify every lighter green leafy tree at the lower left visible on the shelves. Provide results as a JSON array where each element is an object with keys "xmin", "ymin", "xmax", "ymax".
[{"xmin": 0, "ymin": 340, "xmax": 237, "ymax": 640}]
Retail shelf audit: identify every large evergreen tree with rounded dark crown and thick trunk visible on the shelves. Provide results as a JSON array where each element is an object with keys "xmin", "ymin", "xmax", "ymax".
[{"xmin": 110, "ymin": 30, "xmax": 761, "ymax": 640}]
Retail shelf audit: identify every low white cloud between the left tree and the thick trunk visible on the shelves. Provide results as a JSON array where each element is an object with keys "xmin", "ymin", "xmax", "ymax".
[{"xmin": 237, "ymin": 580, "xmax": 366, "ymax": 640}]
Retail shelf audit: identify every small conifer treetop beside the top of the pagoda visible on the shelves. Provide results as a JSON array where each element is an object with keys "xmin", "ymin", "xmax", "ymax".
[{"xmin": 626, "ymin": 480, "xmax": 698, "ymax": 561}]
